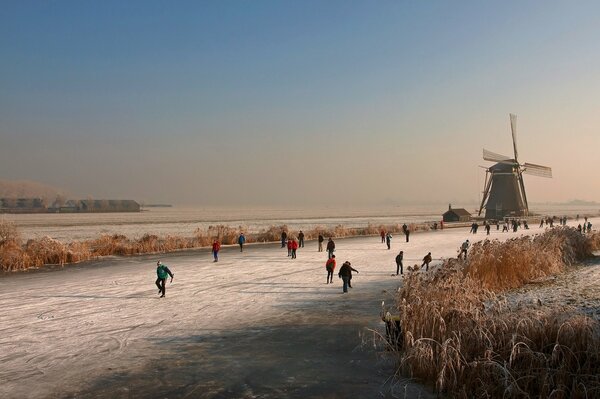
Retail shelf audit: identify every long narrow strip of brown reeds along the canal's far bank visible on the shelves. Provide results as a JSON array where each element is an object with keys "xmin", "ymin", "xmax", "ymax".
[{"xmin": 0, "ymin": 222, "xmax": 429, "ymax": 271}]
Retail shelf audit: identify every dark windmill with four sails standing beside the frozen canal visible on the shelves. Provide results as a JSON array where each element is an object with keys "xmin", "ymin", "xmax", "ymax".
[{"xmin": 479, "ymin": 114, "xmax": 552, "ymax": 219}]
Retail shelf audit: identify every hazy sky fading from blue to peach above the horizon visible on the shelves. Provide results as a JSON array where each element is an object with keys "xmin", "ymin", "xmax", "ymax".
[{"xmin": 0, "ymin": 0, "xmax": 600, "ymax": 205}]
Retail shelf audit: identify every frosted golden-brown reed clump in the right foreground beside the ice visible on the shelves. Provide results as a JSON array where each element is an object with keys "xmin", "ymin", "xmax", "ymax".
[{"xmin": 398, "ymin": 228, "xmax": 600, "ymax": 398}]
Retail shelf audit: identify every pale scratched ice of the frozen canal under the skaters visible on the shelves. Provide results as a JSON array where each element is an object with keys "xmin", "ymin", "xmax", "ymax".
[{"xmin": 0, "ymin": 220, "xmax": 600, "ymax": 398}]
